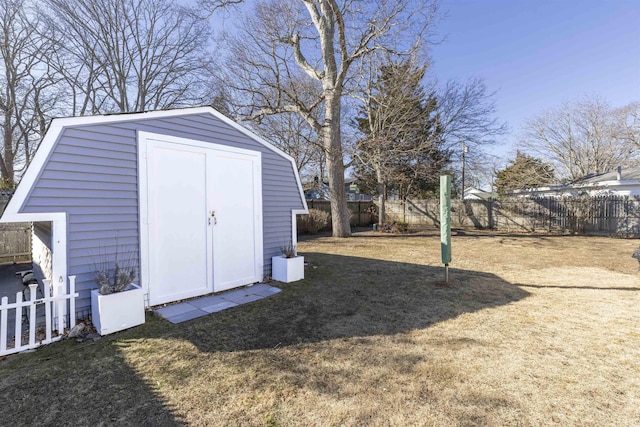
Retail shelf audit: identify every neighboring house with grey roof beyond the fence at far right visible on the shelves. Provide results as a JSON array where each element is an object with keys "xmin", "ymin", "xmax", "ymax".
[{"xmin": 509, "ymin": 167, "xmax": 640, "ymax": 197}]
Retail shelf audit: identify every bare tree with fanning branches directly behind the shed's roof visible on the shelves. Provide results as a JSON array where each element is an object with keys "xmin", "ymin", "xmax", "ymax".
[{"xmin": 45, "ymin": 0, "xmax": 218, "ymax": 115}]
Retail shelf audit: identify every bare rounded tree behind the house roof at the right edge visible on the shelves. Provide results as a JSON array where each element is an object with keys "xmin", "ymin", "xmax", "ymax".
[{"xmin": 519, "ymin": 97, "xmax": 640, "ymax": 181}]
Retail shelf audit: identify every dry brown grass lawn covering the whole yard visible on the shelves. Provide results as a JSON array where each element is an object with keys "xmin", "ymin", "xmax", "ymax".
[{"xmin": 0, "ymin": 231, "xmax": 640, "ymax": 426}]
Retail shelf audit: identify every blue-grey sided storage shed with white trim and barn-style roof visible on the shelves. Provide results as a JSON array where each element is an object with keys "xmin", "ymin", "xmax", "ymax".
[{"xmin": 0, "ymin": 107, "xmax": 307, "ymax": 312}]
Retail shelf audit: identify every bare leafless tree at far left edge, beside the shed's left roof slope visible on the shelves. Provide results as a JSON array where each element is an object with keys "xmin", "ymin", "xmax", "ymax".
[{"xmin": 0, "ymin": 0, "xmax": 56, "ymax": 187}]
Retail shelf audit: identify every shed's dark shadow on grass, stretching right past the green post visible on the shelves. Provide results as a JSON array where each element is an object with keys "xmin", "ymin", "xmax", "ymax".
[{"xmin": 178, "ymin": 253, "xmax": 529, "ymax": 352}]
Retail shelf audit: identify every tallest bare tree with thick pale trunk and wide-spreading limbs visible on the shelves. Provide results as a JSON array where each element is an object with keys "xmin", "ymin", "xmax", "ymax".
[{"xmin": 218, "ymin": 0, "xmax": 435, "ymax": 237}]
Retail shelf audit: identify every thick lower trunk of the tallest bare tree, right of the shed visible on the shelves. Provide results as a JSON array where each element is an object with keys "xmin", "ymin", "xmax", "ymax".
[{"xmin": 323, "ymin": 92, "xmax": 351, "ymax": 237}]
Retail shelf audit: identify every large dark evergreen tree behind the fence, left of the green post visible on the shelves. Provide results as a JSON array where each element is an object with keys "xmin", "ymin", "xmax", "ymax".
[{"xmin": 355, "ymin": 60, "xmax": 449, "ymax": 220}]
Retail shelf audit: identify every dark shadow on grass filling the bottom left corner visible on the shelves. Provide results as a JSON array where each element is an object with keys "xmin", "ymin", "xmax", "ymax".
[{"xmin": 0, "ymin": 316, "xmax": 184, "ymax": 426}]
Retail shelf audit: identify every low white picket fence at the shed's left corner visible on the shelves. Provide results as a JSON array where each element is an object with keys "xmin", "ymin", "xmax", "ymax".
[{"xmin": 0, "ymin": 276, "xmax": 78, "ymax": 356}]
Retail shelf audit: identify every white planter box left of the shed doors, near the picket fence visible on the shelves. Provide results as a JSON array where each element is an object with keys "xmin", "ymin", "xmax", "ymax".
[{"xmin": 91, "ymin": 284, "xmax": 144, "ymax": 335}]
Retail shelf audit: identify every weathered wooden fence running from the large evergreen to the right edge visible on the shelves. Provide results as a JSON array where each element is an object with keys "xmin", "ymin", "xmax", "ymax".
[{"xmin": 386, "ymin": 196, "xmax": 640, "ymax": 237}]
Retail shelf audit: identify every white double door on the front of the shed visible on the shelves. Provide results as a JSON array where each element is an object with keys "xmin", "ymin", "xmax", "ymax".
[{"xmin": 139, "ymin": 133, "xmax": 263, "ymax": 305}]
